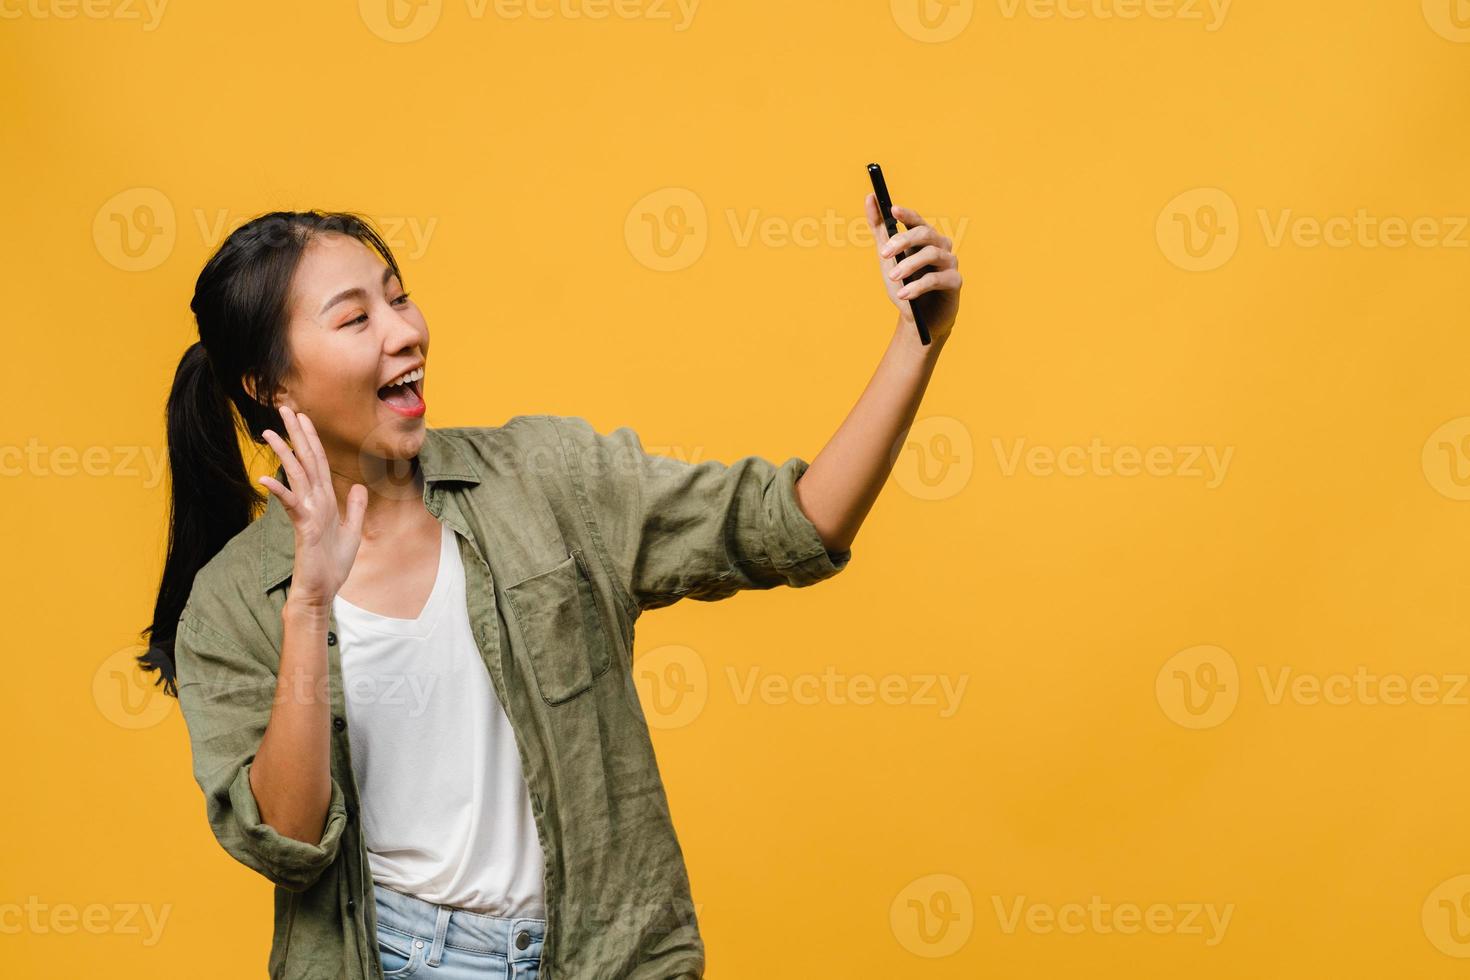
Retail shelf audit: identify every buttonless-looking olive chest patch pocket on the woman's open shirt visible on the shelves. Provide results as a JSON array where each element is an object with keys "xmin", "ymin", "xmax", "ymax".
[{"xmin": 504, "ymin": 548, "xmax": 613, "ymax": 705}]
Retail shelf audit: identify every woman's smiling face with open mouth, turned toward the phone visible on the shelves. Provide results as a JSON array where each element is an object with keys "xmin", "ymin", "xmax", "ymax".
[{"xmin": 276, "ymin": 234, "xmax": 429, "ymax": 473}]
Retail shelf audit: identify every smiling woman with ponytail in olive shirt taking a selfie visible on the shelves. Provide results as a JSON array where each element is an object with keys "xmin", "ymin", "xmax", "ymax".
[{"xmin": 140, "ymin": 202, "xmax": 960, "ymax": 980}]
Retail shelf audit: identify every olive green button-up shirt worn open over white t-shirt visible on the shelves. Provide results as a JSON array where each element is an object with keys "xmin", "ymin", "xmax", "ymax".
[{"xmin": 175, "ymin": 414, "xmax": 851, "ymax": 980}]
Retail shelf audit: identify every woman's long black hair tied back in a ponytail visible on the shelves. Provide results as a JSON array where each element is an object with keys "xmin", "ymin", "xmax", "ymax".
[{"xmin": 138, "ymin": 210, "xmax": 401, "ymax": 698}]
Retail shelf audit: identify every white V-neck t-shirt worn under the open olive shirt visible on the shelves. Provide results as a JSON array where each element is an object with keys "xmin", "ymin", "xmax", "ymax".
[{"xmin": 332, "ymin": 525, "xmax": 545, "ymax": 918}]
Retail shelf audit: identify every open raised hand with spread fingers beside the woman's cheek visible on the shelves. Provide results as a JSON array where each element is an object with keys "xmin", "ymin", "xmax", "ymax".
[{"xmin": 260, "ymin": 406, "xmax": 368, "ymax": 605}]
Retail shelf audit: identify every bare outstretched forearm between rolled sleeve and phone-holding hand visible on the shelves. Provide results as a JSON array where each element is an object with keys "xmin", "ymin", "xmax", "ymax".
[{"xmin": 797, "ymin": 317, "xmax": 945, "ymax": 552}]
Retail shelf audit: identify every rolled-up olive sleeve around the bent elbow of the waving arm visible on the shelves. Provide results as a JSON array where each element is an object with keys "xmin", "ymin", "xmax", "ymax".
[{"xmin": 173, "ymin": 610, "xmax": 347, "ymax": 892}]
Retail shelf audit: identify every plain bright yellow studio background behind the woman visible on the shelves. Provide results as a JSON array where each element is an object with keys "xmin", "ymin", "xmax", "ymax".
[{"xmin": 0, "ymin": 0, "xmax": 1470, "ymax": 979}]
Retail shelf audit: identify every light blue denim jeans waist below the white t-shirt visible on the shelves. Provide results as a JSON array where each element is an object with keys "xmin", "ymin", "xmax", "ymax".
[{"xmin": 373, "ymin": 883, "xmax": 547, "ymax": 980}]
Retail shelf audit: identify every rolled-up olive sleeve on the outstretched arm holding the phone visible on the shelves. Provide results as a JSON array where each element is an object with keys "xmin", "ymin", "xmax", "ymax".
[{"xmin": 553, "ymin": 416, "xmax": 853, "ymax": 610}]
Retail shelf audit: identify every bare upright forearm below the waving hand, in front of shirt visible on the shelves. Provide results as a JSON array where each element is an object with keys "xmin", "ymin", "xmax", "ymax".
[{"xmin": 250, "ymin": 599, "xmax": 332, "ymax": 843}]
